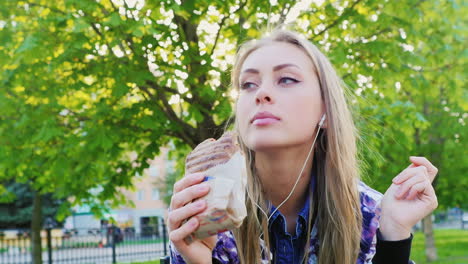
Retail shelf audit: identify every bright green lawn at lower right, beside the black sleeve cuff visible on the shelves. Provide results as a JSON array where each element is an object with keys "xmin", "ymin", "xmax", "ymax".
[{"xmin": 411, "ymin": 229, "xmax": 468, "ymax": 264}]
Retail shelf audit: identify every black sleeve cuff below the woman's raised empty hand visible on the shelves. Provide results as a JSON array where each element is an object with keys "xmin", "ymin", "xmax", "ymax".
[{"xmin": 372, "ymin": 229, "xmax": 413, "ymax": 264}]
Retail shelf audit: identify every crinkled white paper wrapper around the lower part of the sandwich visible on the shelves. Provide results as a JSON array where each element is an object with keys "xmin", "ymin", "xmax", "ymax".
[{"xmin": 193, "ymin": 151, "xmax": 247, "ymax": 239}]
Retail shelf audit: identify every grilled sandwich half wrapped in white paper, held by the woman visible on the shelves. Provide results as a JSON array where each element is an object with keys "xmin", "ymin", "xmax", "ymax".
[{"xmin": 185, "ymin": 132, "xmax": 247, "ymax": 239}]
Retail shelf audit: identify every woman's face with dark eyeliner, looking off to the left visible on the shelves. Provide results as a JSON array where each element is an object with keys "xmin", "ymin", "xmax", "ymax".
[{"xmin": 236, "ymin": 42, "xmax": 324, "ymax": 151}]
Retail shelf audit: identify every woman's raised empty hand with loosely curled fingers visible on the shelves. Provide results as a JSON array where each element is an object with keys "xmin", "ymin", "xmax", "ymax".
[{"xmin": 380, "ymin": 157, "xmax": 438, "ymax": 240}]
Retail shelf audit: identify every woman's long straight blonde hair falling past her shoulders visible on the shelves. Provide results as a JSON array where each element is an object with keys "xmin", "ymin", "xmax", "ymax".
[{"xmin": 231, "ymin": 29, "xmax": 362, "ymax": 264}]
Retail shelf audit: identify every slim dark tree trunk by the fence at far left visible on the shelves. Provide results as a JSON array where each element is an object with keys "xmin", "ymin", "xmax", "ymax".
[{"xmin": 31, "ymin": 191, "xmax": 42, "ymax": 264}]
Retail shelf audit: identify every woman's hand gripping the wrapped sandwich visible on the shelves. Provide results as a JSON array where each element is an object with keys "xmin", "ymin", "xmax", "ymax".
[{"xmin": 167, "ymin": 173, "xmax": 216, "ymax": 264}]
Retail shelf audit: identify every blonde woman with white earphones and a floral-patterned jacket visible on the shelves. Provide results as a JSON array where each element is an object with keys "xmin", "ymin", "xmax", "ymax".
[{"xmin": 168, "ymin": 30, "xmax": 437, "ymax": 264}]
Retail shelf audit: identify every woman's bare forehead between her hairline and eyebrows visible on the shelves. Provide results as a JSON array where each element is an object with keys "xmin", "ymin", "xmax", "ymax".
[{"xmin": 241, "ymin": 42, "xmax": 314, "ymax": 73}]
